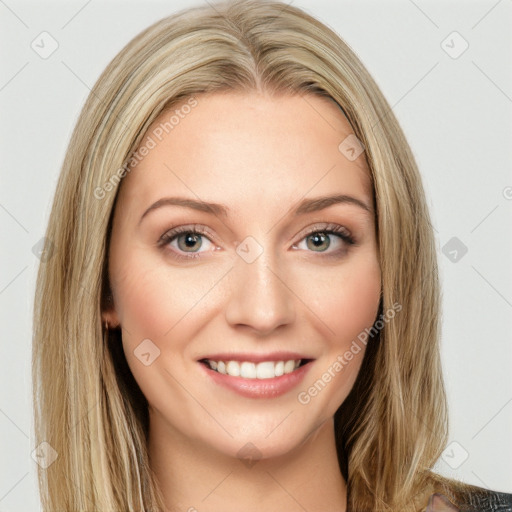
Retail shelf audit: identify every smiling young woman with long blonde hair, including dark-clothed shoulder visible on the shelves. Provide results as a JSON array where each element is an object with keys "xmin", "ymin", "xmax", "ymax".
[{"xmin": 33, "ymin": 1, "xmax": 512, "ymax": 512}]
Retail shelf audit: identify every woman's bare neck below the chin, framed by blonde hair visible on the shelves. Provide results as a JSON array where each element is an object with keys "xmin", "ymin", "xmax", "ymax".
[{"xmin": 149, "ymin": 416, "xmax": 347, "ymax": 512}]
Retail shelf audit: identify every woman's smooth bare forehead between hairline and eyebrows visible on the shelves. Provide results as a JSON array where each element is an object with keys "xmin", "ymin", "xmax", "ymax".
[{"xmin": 116, "ymin": 92, "xmax": 372, "ymax": 216}]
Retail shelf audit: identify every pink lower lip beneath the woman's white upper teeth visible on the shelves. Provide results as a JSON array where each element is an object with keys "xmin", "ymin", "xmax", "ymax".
[{"xmin": 199, "ymin": 361, "xmax": 312, "ymax": 398}]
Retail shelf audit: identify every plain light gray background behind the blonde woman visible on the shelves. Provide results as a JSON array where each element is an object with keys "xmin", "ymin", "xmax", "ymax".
[{"xmin": 0, "ymin": 0, "xmax": 512, "ymax": 512}]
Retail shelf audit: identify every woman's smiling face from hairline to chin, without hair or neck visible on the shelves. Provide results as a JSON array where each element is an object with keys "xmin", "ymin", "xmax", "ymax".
[{"xmin": 105, "ymin": 92, "xmax": 381, "ymax": 458}]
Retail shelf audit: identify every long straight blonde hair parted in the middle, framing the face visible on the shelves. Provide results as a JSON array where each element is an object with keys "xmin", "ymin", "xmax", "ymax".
[{"xmin": 33, "ymin": 0, "xmax": 464, "ymax": 512}]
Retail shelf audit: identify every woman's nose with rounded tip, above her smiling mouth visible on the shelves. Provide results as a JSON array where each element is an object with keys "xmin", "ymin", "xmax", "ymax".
[{"xmin": 225, "ymin": 253, "xmax": 296, "ymax": 336}]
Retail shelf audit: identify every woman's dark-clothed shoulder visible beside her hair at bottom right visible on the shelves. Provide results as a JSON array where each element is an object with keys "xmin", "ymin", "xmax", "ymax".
[{"xmin": 425, "ymin": 481, "xmax": 512, "ymax": 512}]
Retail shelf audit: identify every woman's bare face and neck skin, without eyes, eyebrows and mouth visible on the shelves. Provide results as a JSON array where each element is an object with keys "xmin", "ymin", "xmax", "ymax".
[{"xmin": 103, "ymin": 92, "xmax": 381, "ymax": 512}]
